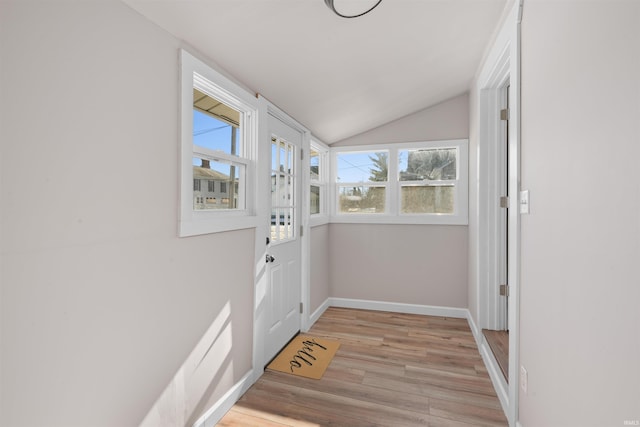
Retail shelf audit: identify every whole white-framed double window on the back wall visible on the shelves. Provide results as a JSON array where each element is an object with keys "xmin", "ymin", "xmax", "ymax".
[{"xmin": 332, "ymin": 140, "xmax": 468, "ymax": 224}]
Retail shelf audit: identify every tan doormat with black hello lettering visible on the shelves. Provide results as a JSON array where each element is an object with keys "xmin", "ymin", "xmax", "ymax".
[{"xmin": 267, "ymin": 335, "xmax": 340, "ymax": 380}]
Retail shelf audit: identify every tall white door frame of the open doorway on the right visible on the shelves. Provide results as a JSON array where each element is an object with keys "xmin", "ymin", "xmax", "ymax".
[{"xmin": 476, "ymin": 0, "xmax": 523, "ymax": 426}]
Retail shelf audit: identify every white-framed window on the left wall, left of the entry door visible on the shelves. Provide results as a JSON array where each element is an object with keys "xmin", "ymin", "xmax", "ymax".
[{"xmin": 180, "ymin": 51, "xmax": 257, "ymax": 236}]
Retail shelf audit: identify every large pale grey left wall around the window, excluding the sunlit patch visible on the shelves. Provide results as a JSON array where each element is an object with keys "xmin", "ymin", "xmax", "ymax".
[{"xmin": 0, "ymin": 1, "xmax": 254, "ymax": 427}]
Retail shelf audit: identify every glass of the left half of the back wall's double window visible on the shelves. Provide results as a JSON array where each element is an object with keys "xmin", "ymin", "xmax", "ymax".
[{"xmin": 336, "ymin": 151, "xmax": 389, "ymax": 214}]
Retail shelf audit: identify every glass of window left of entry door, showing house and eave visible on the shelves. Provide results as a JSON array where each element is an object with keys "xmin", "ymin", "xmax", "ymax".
[{"xmin": 193, "ymin": 88, "xmax": 245, "ymax": 210}]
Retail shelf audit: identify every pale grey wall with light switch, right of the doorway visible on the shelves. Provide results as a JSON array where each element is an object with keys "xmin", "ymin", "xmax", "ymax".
[{"xmin": 520, "ymin": 0, "xmax": 640, "ymax": 427}]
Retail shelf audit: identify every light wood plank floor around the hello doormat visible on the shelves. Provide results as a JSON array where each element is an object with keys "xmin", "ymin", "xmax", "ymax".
[{"xmin": 218, "ymin": 307, "xmax": 507, "ymax": 427}]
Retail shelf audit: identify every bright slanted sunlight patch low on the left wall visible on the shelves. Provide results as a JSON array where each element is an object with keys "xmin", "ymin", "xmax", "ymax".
[{"xmin": 140, "ymin": 301, "xmax": 234, "ymax": 427}]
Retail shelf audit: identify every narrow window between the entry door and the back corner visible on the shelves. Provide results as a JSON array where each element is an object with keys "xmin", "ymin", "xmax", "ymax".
[{"xmin": 309, "ymin": 141, "xmax": 329, "ymax": 225}]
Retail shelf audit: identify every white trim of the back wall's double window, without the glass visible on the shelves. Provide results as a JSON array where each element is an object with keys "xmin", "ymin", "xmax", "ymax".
[{"xmin": 330, "ymin": 139, "xmax": 469, "ymax": 225}]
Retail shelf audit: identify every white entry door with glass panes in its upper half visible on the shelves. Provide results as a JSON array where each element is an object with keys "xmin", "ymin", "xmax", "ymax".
[{"xmin": 264, "ymin": 114, "xmax": 303, "ymax": 361}]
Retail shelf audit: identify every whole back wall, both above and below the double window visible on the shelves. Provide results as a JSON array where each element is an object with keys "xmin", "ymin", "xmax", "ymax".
[{"xmin": 329, "ymin": 94, "xmax": 469, "ymax": 308}]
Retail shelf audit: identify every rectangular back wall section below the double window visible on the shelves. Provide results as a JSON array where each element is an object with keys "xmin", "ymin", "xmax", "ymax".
[{"xmin": 329, "ymin": 224, "xmax": 468, "ymax": 308}]
